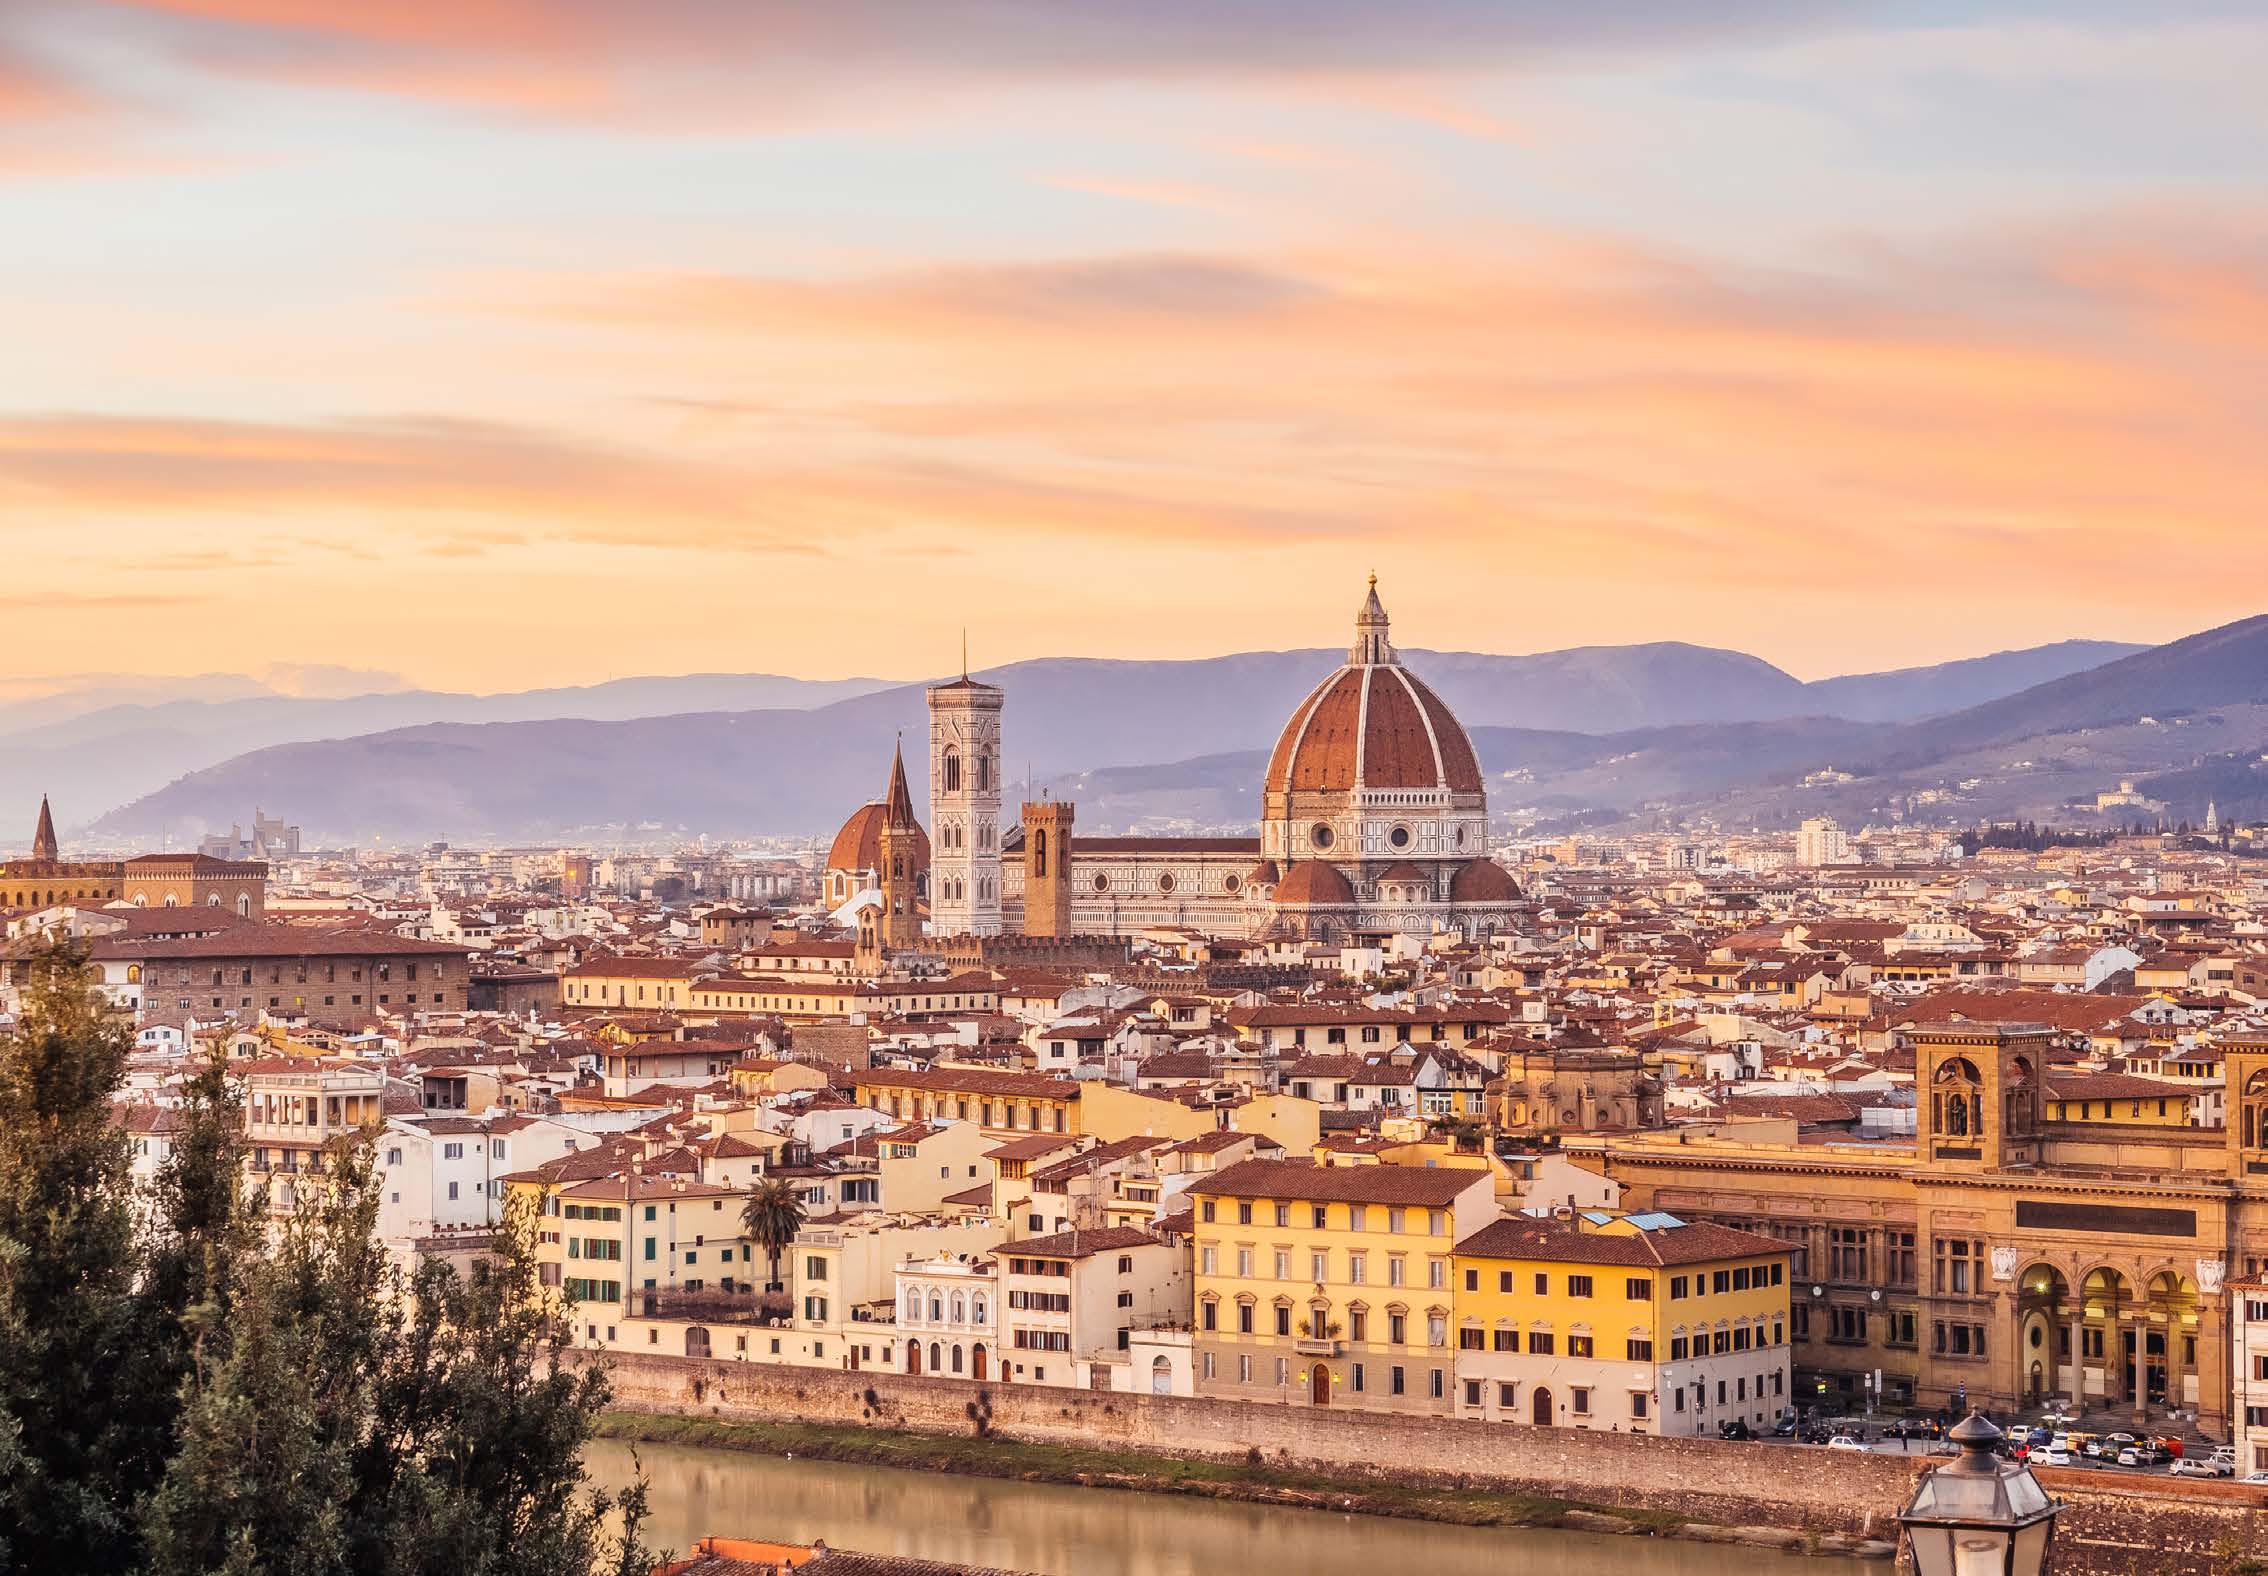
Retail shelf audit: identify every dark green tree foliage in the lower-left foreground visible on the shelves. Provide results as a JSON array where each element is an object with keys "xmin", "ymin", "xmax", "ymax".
[{"xmin": 0, "ymin": 943, "xmax": 655, "ymax": 1576}]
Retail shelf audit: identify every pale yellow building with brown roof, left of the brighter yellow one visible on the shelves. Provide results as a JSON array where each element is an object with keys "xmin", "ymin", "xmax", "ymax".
[{"xmin": 1188, "ymin": 1161, "xmax": 1497, "ymax": 1415}]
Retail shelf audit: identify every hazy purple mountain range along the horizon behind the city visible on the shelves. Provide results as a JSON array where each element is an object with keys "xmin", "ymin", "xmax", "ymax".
[{"xmin": 39, "ymin": 621, "xmax": 2231, "ymax": 846}]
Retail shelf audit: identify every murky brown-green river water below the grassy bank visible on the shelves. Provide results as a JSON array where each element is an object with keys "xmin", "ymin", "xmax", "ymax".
[{"xmin": 587, "ymin": 1440, "xmax": 1889, "ymax": 1576}]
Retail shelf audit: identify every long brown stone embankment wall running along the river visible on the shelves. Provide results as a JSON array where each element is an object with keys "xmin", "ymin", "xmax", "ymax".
[{"xmin": 574, "ymin": 1354, "xmax": 2268, "ymax": 1576}]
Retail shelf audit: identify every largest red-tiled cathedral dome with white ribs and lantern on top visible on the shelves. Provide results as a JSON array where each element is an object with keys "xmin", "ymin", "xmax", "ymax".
[{"xmin": 1266, "ymin": 578, "xmax": 1483, "ymax": 794}]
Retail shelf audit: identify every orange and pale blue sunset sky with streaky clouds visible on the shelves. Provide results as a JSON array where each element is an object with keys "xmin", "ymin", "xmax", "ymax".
[{"xmin": 0, "ymin": 0, "xmax": 2268, "ymax": 689}]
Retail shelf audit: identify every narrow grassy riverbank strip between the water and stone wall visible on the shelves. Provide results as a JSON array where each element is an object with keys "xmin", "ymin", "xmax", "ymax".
[{"xmin": 599, "ymin": 1410, "xmax": 1692, "ymax": 1537}]
